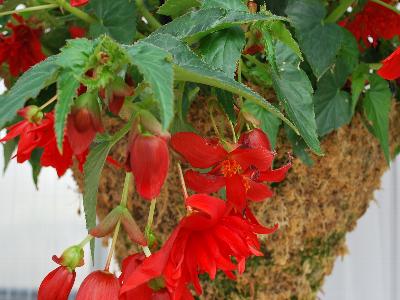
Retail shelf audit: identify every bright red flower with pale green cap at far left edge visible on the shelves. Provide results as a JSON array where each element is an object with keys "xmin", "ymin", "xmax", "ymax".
[{"xmin": 0, "ymin": 106, "xmax": 54, "ymax": 163}]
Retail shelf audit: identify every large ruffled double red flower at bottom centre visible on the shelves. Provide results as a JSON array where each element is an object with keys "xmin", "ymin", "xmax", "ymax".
[{"xmin": 121, "ymin": 194, "xmax": 274, "ymax": 299}]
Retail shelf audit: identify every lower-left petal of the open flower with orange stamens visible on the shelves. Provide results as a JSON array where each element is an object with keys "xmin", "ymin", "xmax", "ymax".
[{"xmin": 185, "ymin": 170, "xmax": 225, "ymax": 194}]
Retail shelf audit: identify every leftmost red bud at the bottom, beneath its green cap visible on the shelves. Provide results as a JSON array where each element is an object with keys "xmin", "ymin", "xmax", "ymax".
[{"xmin": 38, "ymin": 266, "xmax": 76, "ymax": 300}]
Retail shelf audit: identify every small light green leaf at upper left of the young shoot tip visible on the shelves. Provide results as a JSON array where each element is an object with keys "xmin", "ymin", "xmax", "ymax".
[{"xmin": 57, "ymin": 38, "xmax": 95, "ymax": 77}]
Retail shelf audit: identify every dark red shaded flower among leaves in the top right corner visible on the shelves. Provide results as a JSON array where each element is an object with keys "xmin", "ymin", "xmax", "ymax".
[{"xmin": 339, "ymin": 0, "xmax": 400, "ymax": 48}]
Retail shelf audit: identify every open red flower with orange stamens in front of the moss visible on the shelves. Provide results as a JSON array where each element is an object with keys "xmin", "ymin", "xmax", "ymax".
[{"xmin": 171, "ymin": 130, "xmax": 290, "ymax": 211}]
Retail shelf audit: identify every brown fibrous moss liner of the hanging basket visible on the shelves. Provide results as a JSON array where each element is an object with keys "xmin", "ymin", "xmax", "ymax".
[{"xmin": 74, "ymin": 101, "xmax": 400, "ymax": 300}]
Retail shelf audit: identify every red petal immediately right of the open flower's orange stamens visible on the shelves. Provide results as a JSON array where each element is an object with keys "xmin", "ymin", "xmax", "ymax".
[{"xmin": 229, "ymin": 148, "xmax": 274, "ymax": 171}]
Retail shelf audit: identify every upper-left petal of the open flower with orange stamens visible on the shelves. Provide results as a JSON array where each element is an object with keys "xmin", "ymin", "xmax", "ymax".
[{"xmin": 171, "ymin": 132, "xmax": 227, "ymax": 169}]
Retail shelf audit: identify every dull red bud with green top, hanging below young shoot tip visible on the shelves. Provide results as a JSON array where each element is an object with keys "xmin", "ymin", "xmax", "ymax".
[{"xmin": 67, "ymin": 93, "xmax": 103, "ymax": 154}]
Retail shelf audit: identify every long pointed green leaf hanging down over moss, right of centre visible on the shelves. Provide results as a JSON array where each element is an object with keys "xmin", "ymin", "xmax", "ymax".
[{"xmin": 272, "ymin": 42, "xmax": 322, "ymax": 155}]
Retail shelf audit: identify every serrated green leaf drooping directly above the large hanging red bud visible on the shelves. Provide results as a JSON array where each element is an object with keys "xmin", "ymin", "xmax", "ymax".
[{"xmin": 127, "ymin": 42, "xmax": 174, "ymax": 129}]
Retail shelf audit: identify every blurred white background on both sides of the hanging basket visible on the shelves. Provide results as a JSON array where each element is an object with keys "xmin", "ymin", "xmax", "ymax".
[{"xmin": 0, "ymin": 143, "xmax": 400, "ymax": 300}]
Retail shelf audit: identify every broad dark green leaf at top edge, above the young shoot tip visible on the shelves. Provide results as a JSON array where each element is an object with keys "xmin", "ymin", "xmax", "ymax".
[{"xmin": 88, "ymin": 0, "xmax": 136, "ymax": 44}]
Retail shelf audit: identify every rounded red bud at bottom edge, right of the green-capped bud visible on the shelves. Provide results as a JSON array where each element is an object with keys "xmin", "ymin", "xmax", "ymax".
[{"xmin": 76, "ymin": 271, "xmax": 121, "ymax": 300}]
